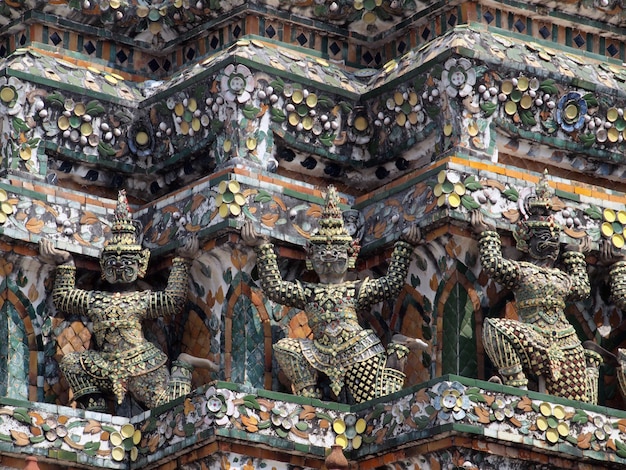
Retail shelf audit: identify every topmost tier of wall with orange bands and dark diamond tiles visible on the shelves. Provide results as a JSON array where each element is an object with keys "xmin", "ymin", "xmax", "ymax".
[{"xmin": 6, "ymin": 0, "xmax": 626, "ymax": 72}]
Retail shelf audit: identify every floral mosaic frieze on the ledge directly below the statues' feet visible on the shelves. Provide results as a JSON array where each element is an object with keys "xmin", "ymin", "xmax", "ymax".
[{"xmin": 0, "ymin": 379, "xmax": 626, "ymax": 468}]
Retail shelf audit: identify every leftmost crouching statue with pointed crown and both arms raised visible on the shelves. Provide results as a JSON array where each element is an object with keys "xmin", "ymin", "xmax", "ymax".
[{"xmin": 40, "ymin": 191, "xmax": 216, "ymax": 410}]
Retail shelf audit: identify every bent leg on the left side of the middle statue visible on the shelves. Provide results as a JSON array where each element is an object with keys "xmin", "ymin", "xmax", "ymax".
[{"xmin": 274, "ymin": 338, "xmax": 322, "ymax": 398}]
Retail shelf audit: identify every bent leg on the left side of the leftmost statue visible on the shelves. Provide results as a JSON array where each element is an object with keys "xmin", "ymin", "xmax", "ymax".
[{"xmin": 59, "ymin": 352, "xmax": 111, "ymax": 411}]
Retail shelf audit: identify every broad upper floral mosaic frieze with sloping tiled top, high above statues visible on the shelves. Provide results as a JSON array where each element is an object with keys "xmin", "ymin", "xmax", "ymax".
[{"xmin": 8, "ymin": 29, "xmax": 626, "ymax": 192}]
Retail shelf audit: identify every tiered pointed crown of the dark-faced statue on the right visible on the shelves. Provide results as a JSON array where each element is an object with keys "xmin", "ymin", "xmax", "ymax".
[{"xmin": 513, "ymin": 170, "xmax": 561, "ymax": 251}]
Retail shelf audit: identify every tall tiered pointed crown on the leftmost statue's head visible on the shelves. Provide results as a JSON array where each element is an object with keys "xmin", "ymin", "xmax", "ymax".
[{"xmin": 100, "ymin": 189, "xmax": 150, "ymax": 277}]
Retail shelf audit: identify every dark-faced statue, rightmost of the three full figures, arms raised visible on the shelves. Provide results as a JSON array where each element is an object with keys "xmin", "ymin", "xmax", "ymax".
[{"xmin": 472, "ymin": 173, "xmax": 601, "ymax": 403}]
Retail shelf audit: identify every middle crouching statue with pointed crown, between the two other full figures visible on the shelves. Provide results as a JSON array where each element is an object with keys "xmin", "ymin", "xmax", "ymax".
[{"xmin": 242, "ymin": 186, "xmax": 426, "ymax": 402}]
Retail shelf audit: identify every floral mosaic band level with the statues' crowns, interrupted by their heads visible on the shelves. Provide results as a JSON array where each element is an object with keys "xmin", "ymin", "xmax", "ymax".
[{"xmin": 0, "ymin": 159, "xmax": 626, "ymax": 253}]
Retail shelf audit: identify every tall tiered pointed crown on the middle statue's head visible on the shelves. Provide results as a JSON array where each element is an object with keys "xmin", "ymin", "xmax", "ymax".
[{"xmin": 309, "ymin": 185, "xmax": 359, "ymax": 268}]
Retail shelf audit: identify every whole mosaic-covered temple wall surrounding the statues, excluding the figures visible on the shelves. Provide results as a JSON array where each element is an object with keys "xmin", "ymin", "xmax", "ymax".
[{"xmin": 0, "ymin": 0, "xmax": 626, "ymax": 470}]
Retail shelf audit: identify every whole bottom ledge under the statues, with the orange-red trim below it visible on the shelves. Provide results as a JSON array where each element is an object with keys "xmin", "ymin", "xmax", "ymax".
[{"xmin": 0, "ymin": 376, "xmax": 626, "ymax": 468}]
